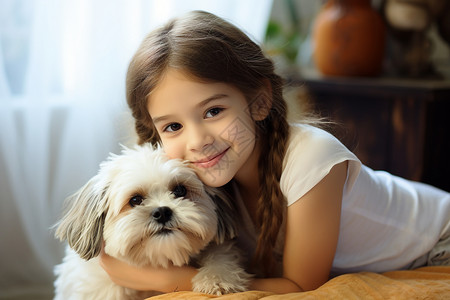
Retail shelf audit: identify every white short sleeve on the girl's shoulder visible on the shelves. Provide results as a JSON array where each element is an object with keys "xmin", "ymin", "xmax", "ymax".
[{"xmin": 280, "ymin": 124, "xmax": 361, "ymax": 206}]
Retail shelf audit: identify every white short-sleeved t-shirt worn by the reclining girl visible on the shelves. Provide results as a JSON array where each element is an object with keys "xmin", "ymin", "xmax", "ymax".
[{"xmin": 237, "ymin": 124, "xmax": 450, "ymax": 273}]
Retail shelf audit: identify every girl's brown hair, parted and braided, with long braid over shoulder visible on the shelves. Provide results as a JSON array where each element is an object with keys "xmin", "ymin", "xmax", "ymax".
[{"xmin": 126, "ymin": 11, "xmax": 289, "ymax": 274}]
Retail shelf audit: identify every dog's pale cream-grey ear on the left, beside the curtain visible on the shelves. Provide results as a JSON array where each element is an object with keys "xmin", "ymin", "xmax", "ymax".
[{"xmin": 55, "ymin": 175, "xmax": 108, "ymax": 260}]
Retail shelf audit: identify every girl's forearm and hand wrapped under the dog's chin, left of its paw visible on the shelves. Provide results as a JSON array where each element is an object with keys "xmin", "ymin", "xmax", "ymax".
[{"xmin": 99, "ymin": 247, "xmax": 197, "ymax": 293}]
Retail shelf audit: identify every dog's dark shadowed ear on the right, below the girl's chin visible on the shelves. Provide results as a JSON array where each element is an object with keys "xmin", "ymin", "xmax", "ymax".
[{"xmin": 206, "ymin": 187, "xmax": 237, "ymax": 244}]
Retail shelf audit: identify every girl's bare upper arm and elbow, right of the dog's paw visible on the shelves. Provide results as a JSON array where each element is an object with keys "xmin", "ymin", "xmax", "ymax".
[{"xmin": 252, "ymin": 161, "xmax": 347, "ymax": 293}]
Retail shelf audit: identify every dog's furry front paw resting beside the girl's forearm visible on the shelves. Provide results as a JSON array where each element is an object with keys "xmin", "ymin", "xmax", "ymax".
[{"xmin": 192, "ymin": 269, "xmax": 251, "ymax": 296}]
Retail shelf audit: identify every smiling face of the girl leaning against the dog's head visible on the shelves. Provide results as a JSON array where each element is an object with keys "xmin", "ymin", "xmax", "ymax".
[{"xmin": 147, "ymin": 69, "xmax": 256, "ymax": 187}]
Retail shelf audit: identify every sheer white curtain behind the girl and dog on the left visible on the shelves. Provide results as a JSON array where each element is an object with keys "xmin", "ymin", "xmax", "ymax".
[{"xmin": 0, "ymin": 0, "xmax": 272, "ymax": 299}]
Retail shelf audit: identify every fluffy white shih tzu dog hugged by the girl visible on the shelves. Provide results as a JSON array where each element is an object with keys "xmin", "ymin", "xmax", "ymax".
[{"xmin": 55, "ymin": 144, "xmax": 250, "ymax": 300}]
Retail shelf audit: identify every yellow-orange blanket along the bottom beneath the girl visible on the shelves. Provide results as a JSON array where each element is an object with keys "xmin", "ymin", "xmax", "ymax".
[{"xmin": 151, "ymin": 266, "xmax": 450, "ymax": 300}]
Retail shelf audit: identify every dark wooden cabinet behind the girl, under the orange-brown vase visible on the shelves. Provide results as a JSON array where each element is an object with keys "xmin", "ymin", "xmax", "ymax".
[{"xmin": 301, "ymin": 77, "xmax": 450, "ymax": 191}]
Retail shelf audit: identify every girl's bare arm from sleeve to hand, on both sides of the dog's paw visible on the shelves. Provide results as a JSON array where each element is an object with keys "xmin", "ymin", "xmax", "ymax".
[{"xmin": 100, "ymin": 162, "xmax": 347, "ymax": 293}]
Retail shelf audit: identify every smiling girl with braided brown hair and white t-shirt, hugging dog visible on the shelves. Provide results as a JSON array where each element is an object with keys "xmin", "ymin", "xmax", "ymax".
[{"xmin": 102, "ymin": 11, "xmax": 450, "ymax": 293}]
